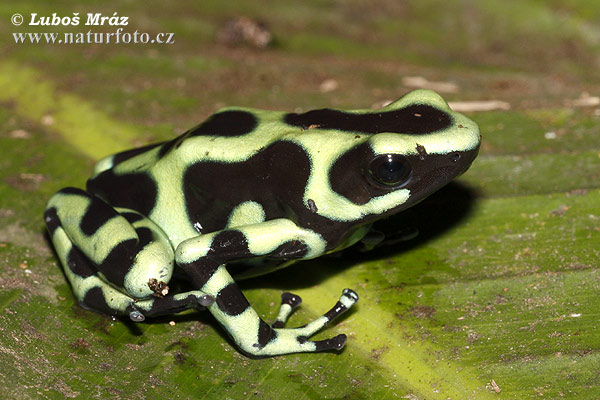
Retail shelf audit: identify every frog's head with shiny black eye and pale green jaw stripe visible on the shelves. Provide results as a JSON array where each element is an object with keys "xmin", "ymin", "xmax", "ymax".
[{"xmin": 300, "ymin": 90, "xmax": 480, "ymax": 222}]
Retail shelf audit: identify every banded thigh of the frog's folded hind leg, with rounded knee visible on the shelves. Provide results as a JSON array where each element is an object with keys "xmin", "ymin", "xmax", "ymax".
[{"xmin": 46, "ymin": 188, "xmax": 174, "ymax": 298}]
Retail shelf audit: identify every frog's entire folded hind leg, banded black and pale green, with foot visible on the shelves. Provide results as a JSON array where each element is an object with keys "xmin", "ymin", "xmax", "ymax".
[{"xmin": 44, "ymin": 188, "xmax": 210, "ymax": 321}]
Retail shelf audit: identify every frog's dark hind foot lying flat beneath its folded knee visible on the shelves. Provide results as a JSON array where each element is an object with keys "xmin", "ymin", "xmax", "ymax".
[{"xmin": 127, "ymin": 290, "xmax": 215, "ymax": 322}]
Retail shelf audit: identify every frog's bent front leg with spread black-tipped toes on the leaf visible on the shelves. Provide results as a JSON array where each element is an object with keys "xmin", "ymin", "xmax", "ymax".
[{"xmin": 175, "ymin": 219, "xmax": 358, "ymax": 357}]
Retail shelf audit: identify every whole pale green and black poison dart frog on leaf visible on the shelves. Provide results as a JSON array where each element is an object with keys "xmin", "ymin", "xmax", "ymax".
[{"xmin": 44, "ymin": 90, "xmax": 481, "ymax": 358}]
